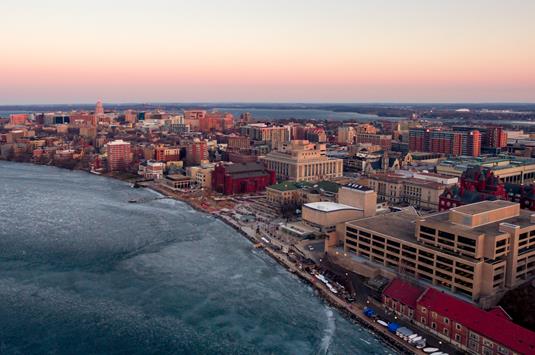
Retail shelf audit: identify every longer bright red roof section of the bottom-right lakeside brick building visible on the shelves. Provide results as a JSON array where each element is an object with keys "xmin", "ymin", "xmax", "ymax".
[{"xmin": 418, "ymin": 288, "xmax": 535, "ymax": 354}]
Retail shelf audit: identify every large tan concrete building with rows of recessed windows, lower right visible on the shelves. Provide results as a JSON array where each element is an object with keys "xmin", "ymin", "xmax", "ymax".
[{"xmin": 343, "ymin": 200, "xmax": 535, "ymax": 307}]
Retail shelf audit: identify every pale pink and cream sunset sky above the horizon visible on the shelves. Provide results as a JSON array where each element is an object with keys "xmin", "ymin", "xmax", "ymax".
[{"xmin": 0, "ymin": 0, "xmax": 535, "ymax": 105}]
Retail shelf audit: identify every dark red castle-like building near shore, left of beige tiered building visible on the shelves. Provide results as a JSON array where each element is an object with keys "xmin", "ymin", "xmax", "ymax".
[{"xmin": 212, "ymin": 163, "xmax": 276, "ymax": 195}]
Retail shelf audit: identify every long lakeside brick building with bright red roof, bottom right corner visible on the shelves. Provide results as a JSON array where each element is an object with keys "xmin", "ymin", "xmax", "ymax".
[{"xmin": 383, "ymin": 279, "xmax": 535, "ymax": 355}]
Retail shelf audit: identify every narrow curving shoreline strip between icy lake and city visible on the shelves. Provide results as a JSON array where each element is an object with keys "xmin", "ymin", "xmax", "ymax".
[{"xmin": 0, "ymin": 160, "xmax": 425, "ymax": 354}]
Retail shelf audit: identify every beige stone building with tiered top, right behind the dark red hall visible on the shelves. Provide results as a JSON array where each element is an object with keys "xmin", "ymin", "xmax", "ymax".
[{"xmin": 260, "ymin": 140, "xmax": 343, "ymax": 181}]
